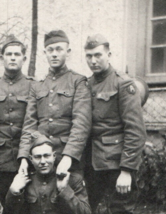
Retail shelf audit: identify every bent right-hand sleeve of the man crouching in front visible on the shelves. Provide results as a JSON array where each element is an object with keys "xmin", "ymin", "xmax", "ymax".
[{"xmin": 57, "ymin": 174, "xmax": 91, "ymax": 214}]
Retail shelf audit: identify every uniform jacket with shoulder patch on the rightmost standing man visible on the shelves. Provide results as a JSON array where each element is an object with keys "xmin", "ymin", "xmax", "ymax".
[{"xmin": 89, "ymin": 66, "xmax": 146, "ymax": 171}]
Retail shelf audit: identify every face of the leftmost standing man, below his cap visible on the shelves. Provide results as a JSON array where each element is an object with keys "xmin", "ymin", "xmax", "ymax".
[{"xmin": 2, "ymin": 45, "xmax": 26, "ymax": 72}]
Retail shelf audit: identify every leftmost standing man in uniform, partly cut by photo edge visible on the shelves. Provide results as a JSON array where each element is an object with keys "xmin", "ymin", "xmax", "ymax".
[{"xmin": 0, "ymin": 35, "xmax": 34, "ymax": 205}]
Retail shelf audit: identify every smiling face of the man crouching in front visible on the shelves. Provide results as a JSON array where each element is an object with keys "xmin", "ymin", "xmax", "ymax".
[{"xmin": 30, "ymin": 144, "xmax": 55, "ymax": 175}]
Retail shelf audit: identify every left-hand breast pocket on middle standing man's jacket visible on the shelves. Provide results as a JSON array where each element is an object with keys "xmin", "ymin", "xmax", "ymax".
[{"xmin": 36, "ymin": 91, "xmax": 49, "ymax": 119}]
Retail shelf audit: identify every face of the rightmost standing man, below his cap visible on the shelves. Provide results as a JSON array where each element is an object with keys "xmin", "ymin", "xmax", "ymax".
[{"xmin": 85, "ymin": 45, "xmax": 110, "ymax": 73}]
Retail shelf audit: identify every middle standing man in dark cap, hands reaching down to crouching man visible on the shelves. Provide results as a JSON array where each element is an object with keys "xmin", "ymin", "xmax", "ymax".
[{"xmin": 18, "ymin": 30, "xmax": 91, "ymax": 181}]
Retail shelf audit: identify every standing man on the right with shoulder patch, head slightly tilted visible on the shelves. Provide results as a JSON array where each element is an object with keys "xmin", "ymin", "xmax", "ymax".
[{"xmin": 85, "ymin": 34, "xmax": 146, "ymax": 214}]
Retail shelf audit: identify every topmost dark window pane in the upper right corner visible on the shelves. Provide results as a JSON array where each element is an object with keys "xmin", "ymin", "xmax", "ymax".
[{"xmin": 153, "ymin": 0, "xmax": 166, "ymax": 16}]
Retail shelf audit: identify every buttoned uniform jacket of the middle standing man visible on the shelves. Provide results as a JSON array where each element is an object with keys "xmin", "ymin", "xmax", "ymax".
[{"xmin": 18, "ymin": 67, "xmax": 91, "ymax": 167}]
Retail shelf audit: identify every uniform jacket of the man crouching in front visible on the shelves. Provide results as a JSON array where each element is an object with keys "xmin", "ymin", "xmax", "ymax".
[{"xmin": 4, "ymin": 172, "xmax": 91, "ymax": 214}]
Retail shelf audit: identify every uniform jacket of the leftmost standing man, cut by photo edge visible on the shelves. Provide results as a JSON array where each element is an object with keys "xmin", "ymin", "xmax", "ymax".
[{"xmin": 0, "ymin": 72, "xmax": 32, "ymax": 172}]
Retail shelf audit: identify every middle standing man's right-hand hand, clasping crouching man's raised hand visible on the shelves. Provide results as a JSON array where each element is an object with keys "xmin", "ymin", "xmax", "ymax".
[{"xmin": 56, "ymin": 155, "xmax": 72, "ymax": 177}]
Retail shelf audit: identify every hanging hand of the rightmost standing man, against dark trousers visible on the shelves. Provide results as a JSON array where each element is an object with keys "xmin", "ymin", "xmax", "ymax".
[{"xmin": 116, "ymin": 171, "xmax": 132, "ymax": 194}]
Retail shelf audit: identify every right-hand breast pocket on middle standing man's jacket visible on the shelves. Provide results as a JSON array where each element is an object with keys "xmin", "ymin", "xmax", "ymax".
[{"xmin": 57, "ymin": 89, "xmax": 74, "ymax": 117}]
